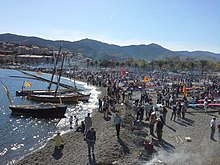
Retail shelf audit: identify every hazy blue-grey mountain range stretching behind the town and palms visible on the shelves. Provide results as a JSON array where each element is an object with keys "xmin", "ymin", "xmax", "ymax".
[{"xmin": 0, "ymin": 33, "xmax": 220, "ymax": 61}]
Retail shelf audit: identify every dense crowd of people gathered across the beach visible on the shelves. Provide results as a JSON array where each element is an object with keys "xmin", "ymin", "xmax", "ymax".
[{"xmin": 55, "ymin": 71, "xmax": 220, "ymax": 155}]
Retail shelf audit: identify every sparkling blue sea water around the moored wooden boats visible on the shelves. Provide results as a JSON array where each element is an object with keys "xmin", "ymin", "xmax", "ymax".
[{"xmin": 0, "ymin": 69, "xmax": 100, "ymax": 165}]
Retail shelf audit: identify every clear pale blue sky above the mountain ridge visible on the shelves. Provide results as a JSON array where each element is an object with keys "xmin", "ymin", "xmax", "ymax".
[{"xmin": 0, "ymin": 0, "xmax": 220, "ymax": 53}]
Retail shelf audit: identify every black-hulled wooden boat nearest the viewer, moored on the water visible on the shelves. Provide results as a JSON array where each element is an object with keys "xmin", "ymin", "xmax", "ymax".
[{"xmin": 9, "ymin": 103, "xmax": 67, "ymax": 118}]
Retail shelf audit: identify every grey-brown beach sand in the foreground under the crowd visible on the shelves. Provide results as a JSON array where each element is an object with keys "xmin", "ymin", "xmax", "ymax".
[{"xmin": 15, "ymin": 88, "xmax": 220, "ymax": 165}]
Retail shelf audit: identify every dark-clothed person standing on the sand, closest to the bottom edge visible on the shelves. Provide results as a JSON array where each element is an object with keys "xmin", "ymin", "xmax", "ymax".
[{"xmin": 85, "ymin": 127, "xmax": 96, "ymax": 156}]
